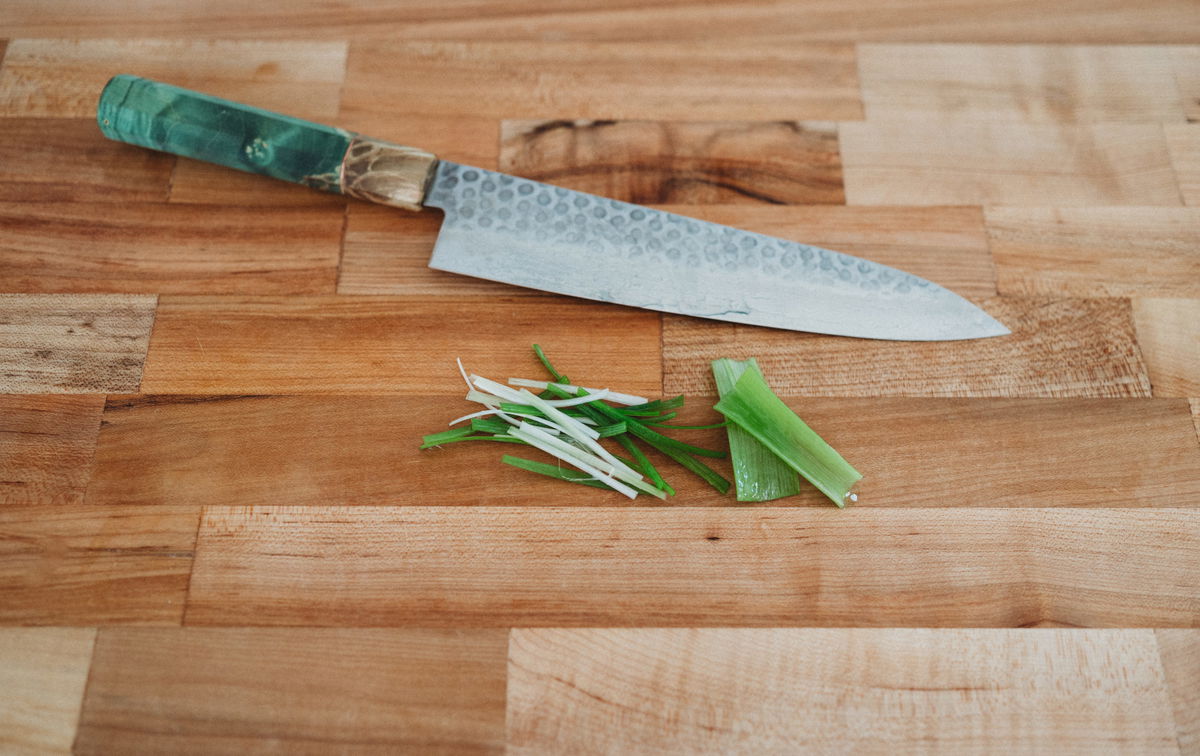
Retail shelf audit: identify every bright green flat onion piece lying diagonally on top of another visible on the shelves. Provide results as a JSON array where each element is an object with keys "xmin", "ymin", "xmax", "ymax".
[{"xmin": 715, "ymin": 364, "xmax": 863, "ymax": 506}]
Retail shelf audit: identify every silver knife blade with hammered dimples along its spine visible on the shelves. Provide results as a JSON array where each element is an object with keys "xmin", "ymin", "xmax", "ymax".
[{"xmin": 425, "ymin": 161, "xmax": 1008, "ymax": 340}]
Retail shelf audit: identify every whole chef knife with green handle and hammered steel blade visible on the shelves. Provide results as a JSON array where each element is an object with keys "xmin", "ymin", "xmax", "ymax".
[{"xmin": 96, "ymin": 74, "xmax": 1009, "ymax": 341}]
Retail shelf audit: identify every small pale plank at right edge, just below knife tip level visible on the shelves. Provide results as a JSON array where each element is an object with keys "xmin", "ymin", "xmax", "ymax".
[{"xmin": 1133, "ymin": 298, "xmax": 1200, "ymax": 396}]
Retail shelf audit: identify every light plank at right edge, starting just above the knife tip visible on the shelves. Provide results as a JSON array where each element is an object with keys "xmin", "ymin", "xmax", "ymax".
[{"xmin": 985, "ymin": 208, "xmax": 1200, "ymax": 296}]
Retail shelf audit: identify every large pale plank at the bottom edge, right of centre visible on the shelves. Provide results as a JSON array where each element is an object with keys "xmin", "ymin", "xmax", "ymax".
[{"xmin": 508, "ymin": 629, "xmax": 1177, "ymax": 754}]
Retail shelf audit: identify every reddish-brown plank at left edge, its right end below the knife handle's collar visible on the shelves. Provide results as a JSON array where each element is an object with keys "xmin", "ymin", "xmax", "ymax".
[{"xmin": 0, "ymin": 202, "xmax": 343, "ymax": 294}]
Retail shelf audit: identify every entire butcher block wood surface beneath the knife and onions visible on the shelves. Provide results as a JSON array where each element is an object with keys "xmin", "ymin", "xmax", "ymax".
[{"xmin": 0, "ymin": 0, "xmax": 1200, "ymax": 754}]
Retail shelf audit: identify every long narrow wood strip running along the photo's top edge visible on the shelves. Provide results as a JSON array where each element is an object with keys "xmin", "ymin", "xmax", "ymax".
[{"xmin": 5, "ymin": 0, "xmax": 1200, "ymax": 43}]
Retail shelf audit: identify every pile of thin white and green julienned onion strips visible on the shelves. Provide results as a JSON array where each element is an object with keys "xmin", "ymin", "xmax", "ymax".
[{"xmin": 421, "ymin": 344, "xmax": 730, "ymax": 498}]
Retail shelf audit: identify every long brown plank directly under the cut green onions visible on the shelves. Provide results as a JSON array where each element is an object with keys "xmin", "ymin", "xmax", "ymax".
[{"xmin": 88, "ymin": 396, "xmax": 1200, "ymax": 509}]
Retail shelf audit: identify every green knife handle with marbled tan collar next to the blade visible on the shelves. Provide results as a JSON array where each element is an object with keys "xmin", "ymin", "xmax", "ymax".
[{"xmin": 96, "ymin": 73, "xmax": 437, "ymax": 210}]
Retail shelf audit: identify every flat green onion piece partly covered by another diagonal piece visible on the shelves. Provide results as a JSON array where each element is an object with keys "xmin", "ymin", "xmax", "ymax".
[{"xmin": 713, "ymin": 358, "xmax": 800, "ymax": 502}]
